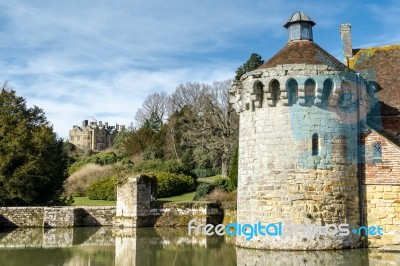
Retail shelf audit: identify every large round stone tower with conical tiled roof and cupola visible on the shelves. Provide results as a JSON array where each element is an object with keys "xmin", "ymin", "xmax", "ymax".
[{"xmin": 230, "ymin": 12, "xmax": 368, "ymax": 250}]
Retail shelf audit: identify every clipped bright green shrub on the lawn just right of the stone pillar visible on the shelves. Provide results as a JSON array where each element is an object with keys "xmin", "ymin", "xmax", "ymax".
[{"xmin": 152, "ymin": 172, "xmax": 196, "ymax": 198}]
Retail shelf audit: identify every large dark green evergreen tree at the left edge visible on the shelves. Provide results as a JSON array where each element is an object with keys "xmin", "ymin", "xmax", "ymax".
[{"xmin": 0, "ymin": 86, "xmax": 67, "ymax": 206}]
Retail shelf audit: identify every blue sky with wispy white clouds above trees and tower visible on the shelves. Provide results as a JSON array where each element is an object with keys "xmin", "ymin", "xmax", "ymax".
[{"xmin": 0, "ymin": 0, "xmax": 400, "ymax": 138}]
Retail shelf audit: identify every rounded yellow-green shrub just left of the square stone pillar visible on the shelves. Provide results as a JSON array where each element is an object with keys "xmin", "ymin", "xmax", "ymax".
[{"xmin": 88, "ymin": 177, "xmax": 117, "ymax": 200}]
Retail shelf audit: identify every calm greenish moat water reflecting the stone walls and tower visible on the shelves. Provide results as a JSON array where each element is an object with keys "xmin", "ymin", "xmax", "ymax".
[{"xmin": 0, "ymin": 227, "xmax": 400, "ymax": 266}]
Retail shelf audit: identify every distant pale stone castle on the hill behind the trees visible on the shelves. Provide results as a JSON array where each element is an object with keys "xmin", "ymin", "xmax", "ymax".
[{"xmin": 69, "ymin": 120, "xmax": 125, "ymax": 151}]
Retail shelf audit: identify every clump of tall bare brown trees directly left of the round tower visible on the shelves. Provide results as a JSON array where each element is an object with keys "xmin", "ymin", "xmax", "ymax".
[{"xmin": 131, "ymin": 80, "xmax": 238, "ymax": 176}]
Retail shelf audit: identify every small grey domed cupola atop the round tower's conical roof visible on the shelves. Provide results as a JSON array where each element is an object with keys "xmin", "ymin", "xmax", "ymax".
[{"xmin": 284, "ymin": 11, "xmax": 315, "ymax": 42}]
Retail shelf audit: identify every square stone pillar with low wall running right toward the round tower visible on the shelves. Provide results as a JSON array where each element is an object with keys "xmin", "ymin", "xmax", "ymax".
[{"xmin": 114, "ymin": 175, "xmax": 223, "ymax": 227}]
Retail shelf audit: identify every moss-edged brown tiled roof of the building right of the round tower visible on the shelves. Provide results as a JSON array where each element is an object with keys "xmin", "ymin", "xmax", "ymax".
[{"xmin": 349, "ymin": 45, "xmax": 400, "ymax": 115}]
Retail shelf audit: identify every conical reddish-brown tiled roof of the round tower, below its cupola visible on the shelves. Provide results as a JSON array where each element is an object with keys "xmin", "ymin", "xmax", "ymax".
[{"xmin": 259, "ymin": 40, "xmax": 348, "ymax": 70}]
